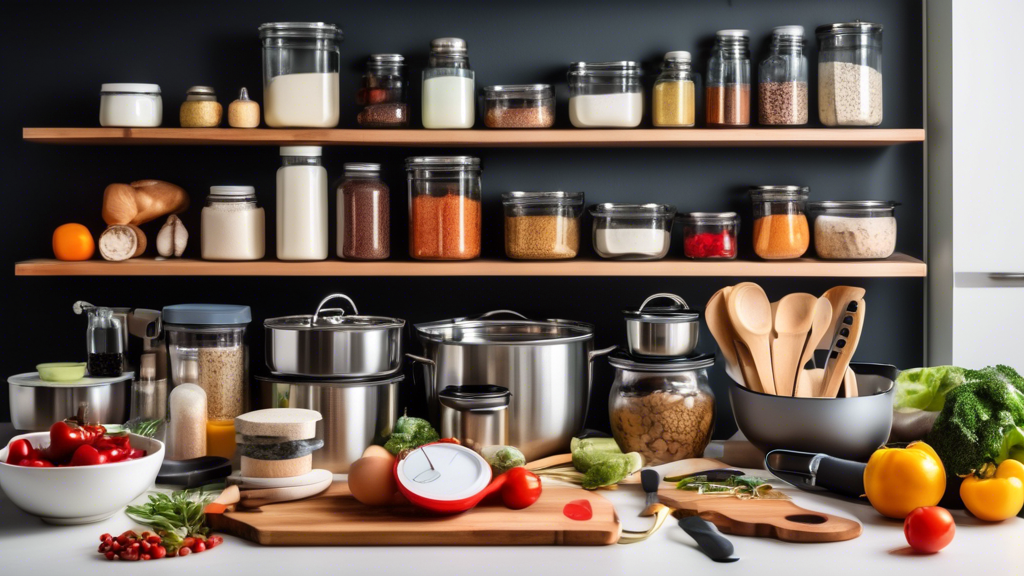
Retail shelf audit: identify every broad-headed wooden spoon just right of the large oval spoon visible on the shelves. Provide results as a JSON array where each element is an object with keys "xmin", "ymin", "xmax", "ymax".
[{"xmin": 771, "ymin": 292, "xmax": 818, "ymax": 396}]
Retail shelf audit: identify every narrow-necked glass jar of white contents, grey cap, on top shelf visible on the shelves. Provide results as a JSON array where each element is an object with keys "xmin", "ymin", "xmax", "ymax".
[{"xmin": 422, "ymin": 38, "xmax": 476, "ymax": 128}]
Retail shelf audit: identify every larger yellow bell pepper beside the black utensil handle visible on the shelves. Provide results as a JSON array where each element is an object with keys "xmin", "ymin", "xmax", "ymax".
[{"xmin": 864, "ymin": 442, "xmax": 946, "ymax": 520}]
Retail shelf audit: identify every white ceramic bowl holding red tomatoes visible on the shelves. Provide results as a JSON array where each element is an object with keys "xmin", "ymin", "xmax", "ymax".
[{"xmin": 0, "ymin": 431, "xmax": 164, "ymax": 524}]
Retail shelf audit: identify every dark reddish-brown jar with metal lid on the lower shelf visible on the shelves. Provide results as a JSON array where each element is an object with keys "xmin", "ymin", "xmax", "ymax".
[{"xmin": 338, "ymin": 162, "xmax": 391, "ymax": 260}]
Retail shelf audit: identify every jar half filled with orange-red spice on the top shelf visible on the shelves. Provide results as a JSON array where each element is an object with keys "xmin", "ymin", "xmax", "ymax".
[{"xmin": 705, "ymin": 30, "xmax": 751, "ymax": 127}]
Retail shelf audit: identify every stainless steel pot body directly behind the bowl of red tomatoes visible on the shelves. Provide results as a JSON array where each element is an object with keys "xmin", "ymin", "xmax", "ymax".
[{"xmin": 7, "ymin": 372, "xmax": 134, "ymax": 430}]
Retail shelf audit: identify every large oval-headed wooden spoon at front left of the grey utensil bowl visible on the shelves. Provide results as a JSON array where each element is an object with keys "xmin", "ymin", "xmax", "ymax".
[{"xmin": 726, "ymin": 283, "xmax": 775, "ymax": 395}]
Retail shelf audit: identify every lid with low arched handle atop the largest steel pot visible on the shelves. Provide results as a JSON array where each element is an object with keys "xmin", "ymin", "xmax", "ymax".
[{"xmin": 415, "ymin": 310, "xmax": 594, "ymax": 344}]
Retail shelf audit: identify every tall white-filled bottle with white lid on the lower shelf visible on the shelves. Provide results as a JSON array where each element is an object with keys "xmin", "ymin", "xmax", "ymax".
[{"xmin": 276, "ymin": 146, "xmax": 328, "ymax": 260}]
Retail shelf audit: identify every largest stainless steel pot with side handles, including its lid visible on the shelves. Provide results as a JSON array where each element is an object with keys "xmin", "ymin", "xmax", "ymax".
[{"xmin": 407, "ymin": 311, "xmax": 614, "ymax": 460}]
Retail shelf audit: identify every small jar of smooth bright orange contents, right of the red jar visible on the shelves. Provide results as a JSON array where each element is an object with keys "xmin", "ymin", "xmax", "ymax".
[{"xmin": 751, "ymin": 186, "xmax": 811, "ymax": 260}]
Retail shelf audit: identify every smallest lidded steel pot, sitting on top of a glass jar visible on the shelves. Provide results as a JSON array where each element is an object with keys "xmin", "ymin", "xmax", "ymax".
[{"xmin": 623, "ymin": 293, "xmax": 700, "ymax": 357}]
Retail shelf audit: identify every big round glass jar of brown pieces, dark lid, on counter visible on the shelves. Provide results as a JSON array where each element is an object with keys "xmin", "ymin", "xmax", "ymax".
[{"xmin": 608, "ymin": 349, "xmax": 716, "ymax": 465}]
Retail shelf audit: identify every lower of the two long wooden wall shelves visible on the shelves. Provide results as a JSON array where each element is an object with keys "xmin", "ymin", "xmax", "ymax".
[{"xmin": 14, "ymin": 253, "xmax": 928, "ymax": 278}]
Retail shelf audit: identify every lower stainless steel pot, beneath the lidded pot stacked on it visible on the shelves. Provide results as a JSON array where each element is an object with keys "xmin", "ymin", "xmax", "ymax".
[{"xmin": 256, "ymin": 374, "xmax": 406, "ymax": 474}]
